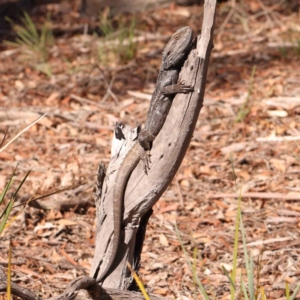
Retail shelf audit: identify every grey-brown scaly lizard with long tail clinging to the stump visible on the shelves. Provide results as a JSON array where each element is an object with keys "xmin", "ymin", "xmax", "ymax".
[{"xmin": 97, "ymin": 26, "xmax": 193, "ymax": 282}]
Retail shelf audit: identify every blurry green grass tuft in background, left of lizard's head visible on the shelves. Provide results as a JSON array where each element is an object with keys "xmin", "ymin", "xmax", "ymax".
[{"xmin": 98, "ymin": 11, "xmax": 137, "ymax": 63}]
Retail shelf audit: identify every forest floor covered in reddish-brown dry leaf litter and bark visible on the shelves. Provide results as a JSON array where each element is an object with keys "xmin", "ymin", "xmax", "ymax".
[{"xmin": 0, "ymin": 0, "xmax": 300, "ymax": 299}]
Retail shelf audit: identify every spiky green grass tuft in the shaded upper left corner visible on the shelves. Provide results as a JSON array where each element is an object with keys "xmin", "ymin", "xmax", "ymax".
[{"xmin": 6, "ymin": 12, "xmax": 53, "ymax": 62}]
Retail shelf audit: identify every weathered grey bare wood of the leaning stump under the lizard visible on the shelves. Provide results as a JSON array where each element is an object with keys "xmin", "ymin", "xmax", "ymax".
[{"xmin": 90, "ymin": 0, "xmax": 216, "ymax": 289}]
